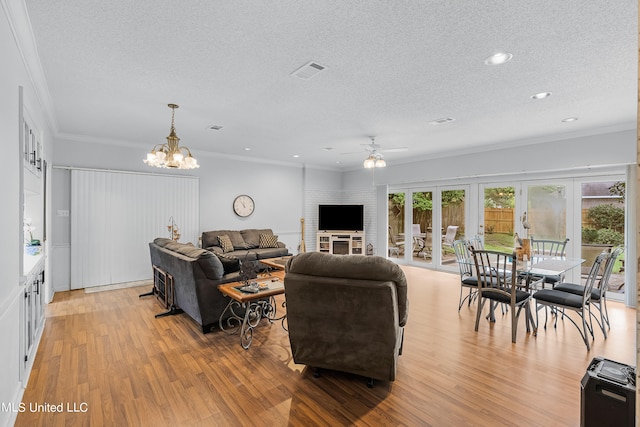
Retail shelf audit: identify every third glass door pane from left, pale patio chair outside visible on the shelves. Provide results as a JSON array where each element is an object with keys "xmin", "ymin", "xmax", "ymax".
[{"xmin": 435, "ymin": 189, "xmax": 466, "ymax": 267}]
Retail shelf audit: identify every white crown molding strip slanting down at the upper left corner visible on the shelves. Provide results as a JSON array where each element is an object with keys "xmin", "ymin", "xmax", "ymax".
[{"xmin": 0, "ymin": 0, "xmax": 58, "ymax": 135}]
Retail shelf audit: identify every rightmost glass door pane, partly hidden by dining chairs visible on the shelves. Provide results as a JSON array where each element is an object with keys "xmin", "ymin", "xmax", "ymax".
[{"xmin": 581, "ymin": 181, "xmax": 625, "ymax": 301}]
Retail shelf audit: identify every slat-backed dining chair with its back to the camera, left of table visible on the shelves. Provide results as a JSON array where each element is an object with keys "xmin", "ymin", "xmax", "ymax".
[{"xmin": 470, "ymin": 247, "xmax": 535, "ymax": 343}]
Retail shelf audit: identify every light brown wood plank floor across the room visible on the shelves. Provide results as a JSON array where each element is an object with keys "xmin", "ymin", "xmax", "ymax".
[{"xmin": 16, "ymin": 267, "xmax": 635, "ymax": 427}]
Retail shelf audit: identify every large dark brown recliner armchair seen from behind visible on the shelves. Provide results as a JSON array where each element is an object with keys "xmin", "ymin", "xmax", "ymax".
[{"xmin": 284, "ymin": 252, "xmax": 408, "ymax": 387}]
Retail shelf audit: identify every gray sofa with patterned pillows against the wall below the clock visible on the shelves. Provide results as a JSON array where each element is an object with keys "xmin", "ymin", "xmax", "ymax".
[{"xmin": 202, "ymin": 228, "xmax": 289, "ymax": 262}]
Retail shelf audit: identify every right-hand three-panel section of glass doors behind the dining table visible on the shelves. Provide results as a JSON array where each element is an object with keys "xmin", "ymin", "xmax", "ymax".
[{"xmin": 478, "ymin": 176, "xmax": 625, "ymax": 301}]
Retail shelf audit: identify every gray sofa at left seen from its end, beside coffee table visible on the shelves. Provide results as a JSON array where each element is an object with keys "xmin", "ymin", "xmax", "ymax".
[{"xmin": 149, "ymin": 238, "xmax": 240, "ymax": 334}]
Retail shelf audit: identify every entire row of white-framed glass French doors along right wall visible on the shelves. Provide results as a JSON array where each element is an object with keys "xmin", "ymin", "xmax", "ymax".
[{"xmin": 389, "ymin": 175, "xmax": 626, "ymax": 300}]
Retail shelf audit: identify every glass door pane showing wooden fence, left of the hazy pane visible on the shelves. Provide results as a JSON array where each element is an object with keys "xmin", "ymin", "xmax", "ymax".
[{"xmin": 483, "ymin": 187, "xmax": 516, "ymax": 252}]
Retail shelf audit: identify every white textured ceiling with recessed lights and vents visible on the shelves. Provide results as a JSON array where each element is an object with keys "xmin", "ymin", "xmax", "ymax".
[{"xmin": 26, "ymin": 0, "xmax": 638, "ymax": 168}]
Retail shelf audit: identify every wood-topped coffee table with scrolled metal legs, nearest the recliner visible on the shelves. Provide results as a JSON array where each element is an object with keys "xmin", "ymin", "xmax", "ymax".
[{"xmin": 218, "ymin": 271, "xmax": 287, "ymax": 350}]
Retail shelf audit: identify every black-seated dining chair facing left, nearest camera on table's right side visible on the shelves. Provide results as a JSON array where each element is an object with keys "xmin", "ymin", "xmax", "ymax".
[{"xmin": 533, "ymin": 253, "xmax": 609, "ymax": 350}]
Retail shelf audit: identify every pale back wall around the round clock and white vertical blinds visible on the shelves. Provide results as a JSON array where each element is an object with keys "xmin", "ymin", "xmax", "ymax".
[{"xmin": 51, "ymin": 139, "xmax": 342, "ymax": 290}]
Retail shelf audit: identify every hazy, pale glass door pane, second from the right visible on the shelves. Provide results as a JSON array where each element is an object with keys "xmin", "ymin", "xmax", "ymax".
[{"xmin": 520, "ymin": 184, "xmax": 567, "ymax": 240}]
